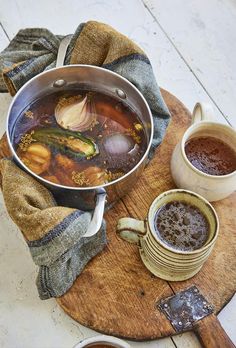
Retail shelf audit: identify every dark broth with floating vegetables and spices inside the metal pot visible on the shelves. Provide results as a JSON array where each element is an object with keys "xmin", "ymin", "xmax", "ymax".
[{"xmin": 14, "ymin": 89, "xmax": 147, "ymax": 187}]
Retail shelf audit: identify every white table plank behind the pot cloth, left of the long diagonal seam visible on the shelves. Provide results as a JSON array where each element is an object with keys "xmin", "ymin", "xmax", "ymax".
[{"xmin": 0, "ymin": 0, "xmax": 227, "ymax": 128}]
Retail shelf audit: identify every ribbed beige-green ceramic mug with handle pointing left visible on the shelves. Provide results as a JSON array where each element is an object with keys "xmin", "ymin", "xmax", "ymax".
[{"xmin": 117, "ymin": 189, "xmax": 219, "ymax": 281}]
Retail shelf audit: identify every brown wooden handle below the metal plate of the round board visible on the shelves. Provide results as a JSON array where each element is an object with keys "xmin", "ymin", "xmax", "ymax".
[{"xmin": 194, "ymin": 314, "xmax": 235, "ymax": 348}]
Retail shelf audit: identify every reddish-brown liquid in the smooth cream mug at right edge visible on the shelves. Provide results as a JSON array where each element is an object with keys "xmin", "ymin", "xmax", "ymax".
[{"xmin": 185, "ymin": 137, "xmax": 236, "ymax": 175}]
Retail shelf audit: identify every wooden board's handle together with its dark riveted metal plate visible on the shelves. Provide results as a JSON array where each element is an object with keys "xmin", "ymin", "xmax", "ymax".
[{"xmin": 157, "ymin": 286, "xmax": 235, "ymax": 348}]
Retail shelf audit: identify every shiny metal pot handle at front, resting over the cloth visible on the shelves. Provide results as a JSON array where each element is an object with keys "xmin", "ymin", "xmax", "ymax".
[{"xmin": 83, "ymin": 189, "xmax": 107, "ymax": 237}]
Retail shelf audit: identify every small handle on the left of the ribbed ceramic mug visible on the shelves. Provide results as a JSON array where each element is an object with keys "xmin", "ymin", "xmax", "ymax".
[{"xmin": 116, "ymin": 217, "xmax": 147, "ymax": 245}]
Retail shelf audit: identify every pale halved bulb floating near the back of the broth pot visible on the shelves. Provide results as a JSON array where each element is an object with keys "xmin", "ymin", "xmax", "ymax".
[{"xmin": 55, "ymin": 95, "xmax": 96, "ymax": 132}]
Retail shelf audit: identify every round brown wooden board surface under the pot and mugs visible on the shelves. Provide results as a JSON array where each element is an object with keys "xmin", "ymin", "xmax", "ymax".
[{"xmin": 57, "ymin": 90, "xmax": 236, "ymax": 340}]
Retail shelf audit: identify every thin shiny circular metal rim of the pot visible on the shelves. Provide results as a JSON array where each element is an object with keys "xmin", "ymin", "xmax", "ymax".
[{"xmin": 6, "ymin": 64, "xmax": 154, "ymax": 191}]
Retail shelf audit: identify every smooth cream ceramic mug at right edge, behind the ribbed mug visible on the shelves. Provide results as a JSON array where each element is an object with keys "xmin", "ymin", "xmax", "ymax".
[{"xmin": 171, "ymin": 103, "xmax": 236, "ymax": 202}]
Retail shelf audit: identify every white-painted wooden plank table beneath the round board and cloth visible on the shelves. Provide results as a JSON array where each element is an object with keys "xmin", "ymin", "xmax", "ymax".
[{"xmin": 0, "ymin": 0, "xmax": 236, "ymax": 348}]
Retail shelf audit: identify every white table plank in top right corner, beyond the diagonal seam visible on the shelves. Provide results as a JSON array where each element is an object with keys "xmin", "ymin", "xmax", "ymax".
[{"xmin": 143, "ymin": 0, "xmax": 236, "ymax": 127}]
